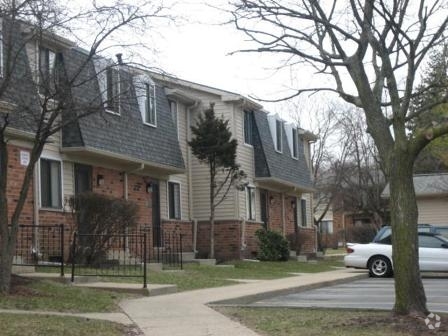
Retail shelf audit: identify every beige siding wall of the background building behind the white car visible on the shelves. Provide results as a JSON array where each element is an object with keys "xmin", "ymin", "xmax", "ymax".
[{"xmin": 417, "ymin": 197, "xmax": 448, "ymax": 225}]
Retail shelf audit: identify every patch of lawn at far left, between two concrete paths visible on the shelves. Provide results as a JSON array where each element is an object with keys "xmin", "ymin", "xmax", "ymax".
[{"xmin": 0, "ymin": 277, "xmax": 130, "ymax": 313}]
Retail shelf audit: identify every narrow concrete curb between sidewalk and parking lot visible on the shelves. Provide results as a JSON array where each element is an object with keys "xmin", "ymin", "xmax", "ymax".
[{"xmin": 206, "ymin": 273, "xmax": 368, "ymax": 306}]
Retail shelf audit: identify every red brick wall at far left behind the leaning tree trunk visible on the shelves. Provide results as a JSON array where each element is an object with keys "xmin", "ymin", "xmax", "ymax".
[{"xmin": 6, "ymin": 145, "xmax": 34, "ymax": 225}]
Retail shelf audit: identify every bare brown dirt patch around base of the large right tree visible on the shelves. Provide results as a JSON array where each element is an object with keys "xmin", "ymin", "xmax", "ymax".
[{"xmin": 339, "ymin": 315, "xmax": 448, "ymax": 336}]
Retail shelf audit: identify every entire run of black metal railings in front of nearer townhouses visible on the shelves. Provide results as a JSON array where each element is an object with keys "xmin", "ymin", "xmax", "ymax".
[{"xmin": 13, "ymin": 224, "xmax": 183, "ymax": 287}]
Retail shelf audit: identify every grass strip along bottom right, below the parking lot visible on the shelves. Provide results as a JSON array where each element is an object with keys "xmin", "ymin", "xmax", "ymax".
[{"xmin": 215, "ymin": 307, "xmax": 448, "ymax": 336}]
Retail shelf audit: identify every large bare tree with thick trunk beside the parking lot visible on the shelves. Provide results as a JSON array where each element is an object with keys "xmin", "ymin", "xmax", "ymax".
[{"xmin": 232, "ymin": 0, "xmax": 448, "ymax": 315}]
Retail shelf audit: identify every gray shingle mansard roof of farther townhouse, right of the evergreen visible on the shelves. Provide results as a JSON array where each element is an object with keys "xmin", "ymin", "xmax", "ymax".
[{"xmin": 254, "ymin": 111, "xmax": 313, "ymax": 189}]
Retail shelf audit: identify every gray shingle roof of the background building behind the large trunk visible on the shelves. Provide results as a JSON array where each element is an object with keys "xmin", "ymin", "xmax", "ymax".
[{"xmin": 381, "ymin": 174, "xmax": 448, "ymax": 198}]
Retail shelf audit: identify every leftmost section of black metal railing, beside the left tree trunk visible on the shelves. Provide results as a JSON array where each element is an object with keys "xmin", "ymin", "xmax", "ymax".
[{"xmin": 13, "ymin": 224, "xmax": 65, "ymax": 276}]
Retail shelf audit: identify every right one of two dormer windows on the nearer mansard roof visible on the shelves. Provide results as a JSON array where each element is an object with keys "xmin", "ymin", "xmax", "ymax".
[{"xmin": 134, "ymin": 75, "xmax": 157, "ymax": 127}]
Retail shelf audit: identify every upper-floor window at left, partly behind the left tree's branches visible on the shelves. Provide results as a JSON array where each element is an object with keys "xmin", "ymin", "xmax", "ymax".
[{"xmin": 39, "ymin": 47, "xmax": 62, "ymax": 95}]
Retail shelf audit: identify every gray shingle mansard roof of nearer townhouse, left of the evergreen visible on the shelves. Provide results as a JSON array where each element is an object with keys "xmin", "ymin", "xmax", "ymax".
[{"xmin": 63, "ymin": 53, "xmax": 184, "ymax": 169}]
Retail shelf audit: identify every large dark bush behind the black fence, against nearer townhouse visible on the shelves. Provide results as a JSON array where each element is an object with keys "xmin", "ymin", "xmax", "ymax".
[{"xmin": 74, "ymin": 193, "xmax": 138, "ymax": 265}]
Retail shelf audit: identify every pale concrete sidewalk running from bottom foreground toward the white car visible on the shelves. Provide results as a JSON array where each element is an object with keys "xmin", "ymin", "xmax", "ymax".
[{"xmin": 120, "ymin": 269, "xmax": 367, "ymax": 336}]
